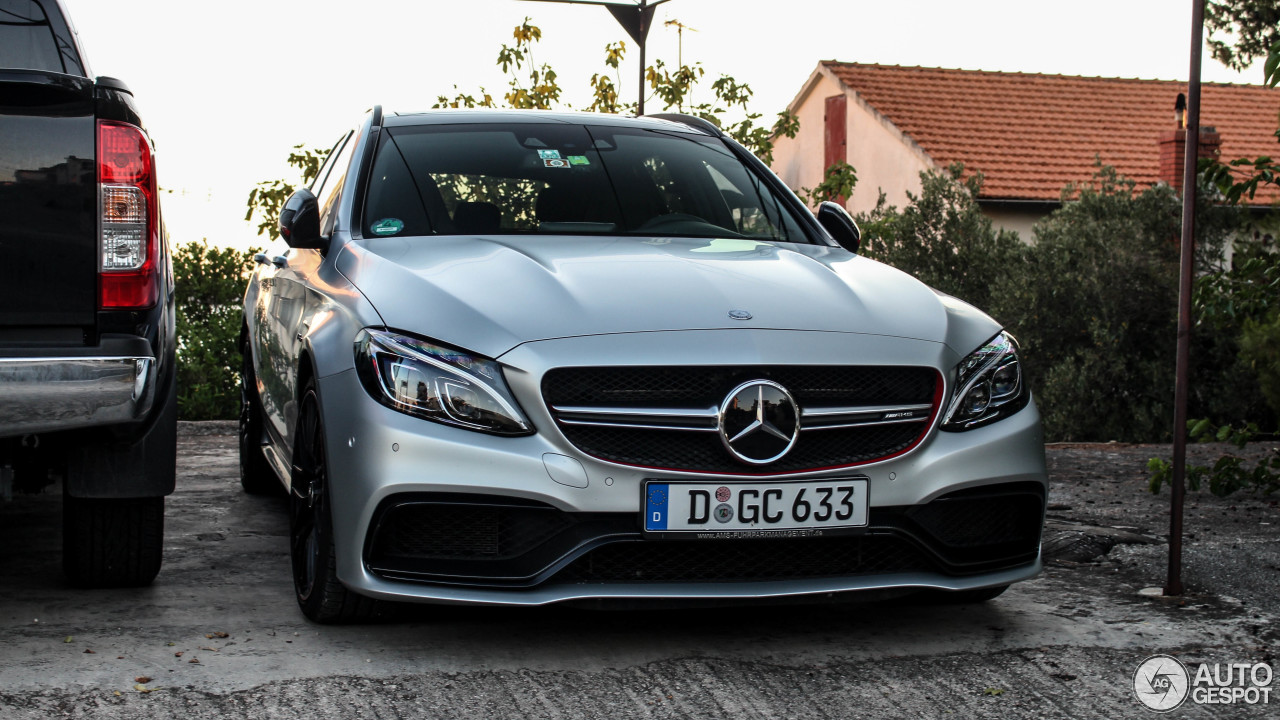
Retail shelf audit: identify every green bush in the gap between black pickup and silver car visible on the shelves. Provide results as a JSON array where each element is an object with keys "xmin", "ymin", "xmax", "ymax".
[{"xmin": 173, "ymin": 241, "xmax": 257, "ymax": 420}]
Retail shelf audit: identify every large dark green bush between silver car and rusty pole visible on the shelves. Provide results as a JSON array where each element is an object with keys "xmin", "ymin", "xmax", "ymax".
[{"xmin": 1006, "ymin": 167, "xmax": 1239, "ymax": 442}]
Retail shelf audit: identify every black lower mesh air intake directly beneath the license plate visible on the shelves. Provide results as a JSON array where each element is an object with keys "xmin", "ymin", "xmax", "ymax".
[{"xmin": 552, "ymin": 536, "xmax": 934, "ymax": 583}]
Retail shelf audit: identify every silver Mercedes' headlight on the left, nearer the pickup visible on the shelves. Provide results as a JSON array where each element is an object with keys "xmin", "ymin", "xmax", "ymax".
[{"xmin": 356, "ymin": 328, "xmax": 534, "ymax": 436}]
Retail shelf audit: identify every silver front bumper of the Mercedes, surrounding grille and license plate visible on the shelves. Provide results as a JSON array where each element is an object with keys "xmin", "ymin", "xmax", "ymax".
[{"xmin": 319, "ymin": 332, "xmax": 1047, "ymax": 605}]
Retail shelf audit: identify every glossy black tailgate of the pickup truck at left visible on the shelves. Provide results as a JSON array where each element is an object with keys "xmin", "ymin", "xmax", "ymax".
[{"xmin": 0, "ymin": 70, "xmax": 99, "ymax": 330}]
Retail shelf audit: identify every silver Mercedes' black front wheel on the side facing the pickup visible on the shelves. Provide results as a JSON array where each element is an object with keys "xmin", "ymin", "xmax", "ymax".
[{"xmin": 289, "ymin": 382, "xmax": 378, "ymax": 624}]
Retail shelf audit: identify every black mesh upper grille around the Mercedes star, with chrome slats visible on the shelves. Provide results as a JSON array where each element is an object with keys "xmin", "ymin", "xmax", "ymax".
[{"xmin": 543, "ymin": 365, "xmax": 940, "ymax": 474}]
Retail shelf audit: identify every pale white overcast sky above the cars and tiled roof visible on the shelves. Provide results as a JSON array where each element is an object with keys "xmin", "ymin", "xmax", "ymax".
[{"xmin": 63, "ymin": 0, "xmax": 1262, "ymax": 249}]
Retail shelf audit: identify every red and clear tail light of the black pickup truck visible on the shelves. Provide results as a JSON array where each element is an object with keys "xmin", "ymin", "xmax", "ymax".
[{"xmin": 97, "ymin": 120, "xmax": 160, "ymax": 310}]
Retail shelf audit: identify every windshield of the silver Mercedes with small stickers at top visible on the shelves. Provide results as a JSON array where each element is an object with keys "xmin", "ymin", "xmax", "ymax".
[{"xmin": 364, "ymin": 123, "xmax": 809, "ymax": 242}]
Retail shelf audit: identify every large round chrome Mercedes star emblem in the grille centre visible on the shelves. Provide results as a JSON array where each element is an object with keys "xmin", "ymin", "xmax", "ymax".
[{"xmin": 718, "ymin": 380, "xmax": 800, "ymax": 465}]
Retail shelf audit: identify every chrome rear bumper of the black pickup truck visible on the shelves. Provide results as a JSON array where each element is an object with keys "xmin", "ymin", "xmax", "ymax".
[{"xmin": 0, "ymin": 356, "xmax": 156, "ymax": 437}]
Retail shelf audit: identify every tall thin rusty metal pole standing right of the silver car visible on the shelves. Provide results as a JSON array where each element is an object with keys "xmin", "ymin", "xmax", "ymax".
[{"xmin": 1165, "ymin": 0, "xmax": 1204, "ymax": 594}]
